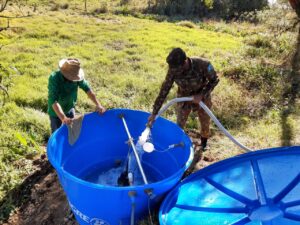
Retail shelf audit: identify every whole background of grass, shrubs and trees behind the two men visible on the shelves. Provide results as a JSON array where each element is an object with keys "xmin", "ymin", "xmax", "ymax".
[{"xmin": 0, "ymin": 0, "xmax": 300, "ymax": 221}]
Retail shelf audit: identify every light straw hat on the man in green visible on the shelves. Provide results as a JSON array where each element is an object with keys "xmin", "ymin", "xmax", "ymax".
[{"xmin": 58, "ymin": 58, "xmax": 84, "ymax": 81}]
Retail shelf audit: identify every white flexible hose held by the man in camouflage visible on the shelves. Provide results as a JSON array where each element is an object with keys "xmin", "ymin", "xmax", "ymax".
[{"xmin": 155, "ymin": 97, "xmax": 253, "ymax": 152}]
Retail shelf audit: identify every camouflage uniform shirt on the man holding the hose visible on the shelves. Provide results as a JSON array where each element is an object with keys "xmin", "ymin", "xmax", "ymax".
[{"xmin": 152, "ymin": 57, "xmax": 219, "ymax": 115}]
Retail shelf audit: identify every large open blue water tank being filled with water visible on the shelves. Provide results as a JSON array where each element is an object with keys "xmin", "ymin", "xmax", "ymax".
[{"xmin": 47, "ymin": 109, "xmax": 193, "ymax": 225}]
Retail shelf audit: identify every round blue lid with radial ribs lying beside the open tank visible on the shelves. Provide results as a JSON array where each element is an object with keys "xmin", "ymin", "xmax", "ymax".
[{"xmin": 159, "ymin": 146, "xmax": 300, "ymax": 225}]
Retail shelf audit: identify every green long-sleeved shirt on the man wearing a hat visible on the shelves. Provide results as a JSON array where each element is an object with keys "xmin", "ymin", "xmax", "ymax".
[{"xmin": 48, "ymin": 70, "xmax": 91, "ymax": 117}]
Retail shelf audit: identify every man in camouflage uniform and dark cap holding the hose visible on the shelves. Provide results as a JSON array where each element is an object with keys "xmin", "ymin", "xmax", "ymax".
[{"xmin": 148, "ymin": 48, "xmax": 219, "ymax": 150}]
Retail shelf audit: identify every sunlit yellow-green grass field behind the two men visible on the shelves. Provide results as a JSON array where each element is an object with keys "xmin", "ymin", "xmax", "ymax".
[{"xmin": 0, "ymin": 2, "xmax": 300, "ymax": 222}]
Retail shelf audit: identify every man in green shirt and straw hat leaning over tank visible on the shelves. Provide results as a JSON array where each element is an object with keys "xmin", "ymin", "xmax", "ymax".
[{"xmin": 48, "ymin": 58, "xmax": 106, "ymax": 133}]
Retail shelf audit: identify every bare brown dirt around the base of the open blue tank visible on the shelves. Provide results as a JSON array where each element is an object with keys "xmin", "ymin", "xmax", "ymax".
[{"xmin": 4, "ymin": 132, "xmax": 214, "ymax": 225}]
